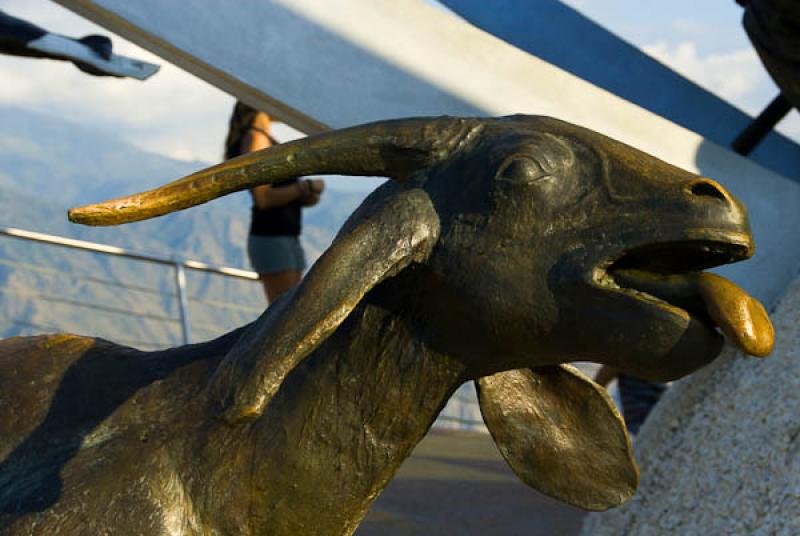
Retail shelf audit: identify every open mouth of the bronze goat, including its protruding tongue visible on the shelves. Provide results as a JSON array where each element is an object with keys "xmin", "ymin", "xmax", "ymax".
[{"xmin": 596, "ymin": 236, "xmax": 774, "ymax": 356}]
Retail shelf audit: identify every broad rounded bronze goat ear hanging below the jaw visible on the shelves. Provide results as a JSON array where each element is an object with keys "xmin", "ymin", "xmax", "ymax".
[{"xmin": 476, "ymin": 365, "xmax": 639, "ymax": 511}]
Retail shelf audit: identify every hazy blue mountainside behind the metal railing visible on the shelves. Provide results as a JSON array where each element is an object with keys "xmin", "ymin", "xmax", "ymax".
[{"xmin": 0, "ymin": 107, "xmax": 364, "ymax": 346}]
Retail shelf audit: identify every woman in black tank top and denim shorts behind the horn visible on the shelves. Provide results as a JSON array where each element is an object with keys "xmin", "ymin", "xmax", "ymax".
[{"xmin": 225, "ymin": 102, "xmax": 325, "ymax": 303}]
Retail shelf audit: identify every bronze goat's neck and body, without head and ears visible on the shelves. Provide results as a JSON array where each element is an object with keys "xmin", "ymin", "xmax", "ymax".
[{"xmin": 0, "ymin": 296, "xmax": 463, "ymax": 535}]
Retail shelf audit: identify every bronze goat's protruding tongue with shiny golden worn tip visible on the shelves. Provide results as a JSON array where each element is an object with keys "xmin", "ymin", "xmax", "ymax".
[{"xmin": 613, "ymin": 270, "xmax": 775, "ymax": 357}]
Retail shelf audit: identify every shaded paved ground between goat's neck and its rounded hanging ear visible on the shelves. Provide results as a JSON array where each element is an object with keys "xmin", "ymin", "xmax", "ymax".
[{"xmin": 356, "ymin": 431, "xmax": 584, "ymax": 536}]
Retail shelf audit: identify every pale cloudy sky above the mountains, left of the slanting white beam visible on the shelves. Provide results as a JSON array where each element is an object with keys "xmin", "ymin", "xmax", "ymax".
[{"xmin": 0, "ymin": 0, "xmax": 233, "ymax": 162}]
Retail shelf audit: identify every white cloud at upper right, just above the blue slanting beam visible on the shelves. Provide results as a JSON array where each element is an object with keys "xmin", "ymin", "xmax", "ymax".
[{"xmin": 642, "ymin": 41, "xmax": 763, "ymax": 112}]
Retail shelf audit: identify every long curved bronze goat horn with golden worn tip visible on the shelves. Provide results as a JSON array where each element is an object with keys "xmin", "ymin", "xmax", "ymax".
[{"xmin": 68, "ymin": 117, "xmax": 481, "ymax": 225}]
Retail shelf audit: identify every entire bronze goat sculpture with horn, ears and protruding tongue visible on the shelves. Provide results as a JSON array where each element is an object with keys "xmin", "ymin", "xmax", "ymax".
[{"xmin": 0, "ymin": 116, "xmax": 773, "ymax": 535}]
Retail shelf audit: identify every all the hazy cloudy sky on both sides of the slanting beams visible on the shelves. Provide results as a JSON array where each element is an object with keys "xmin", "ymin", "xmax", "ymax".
[{"xmin": 0, "ymin": 0, "xmax": 800, "ymax": 169}]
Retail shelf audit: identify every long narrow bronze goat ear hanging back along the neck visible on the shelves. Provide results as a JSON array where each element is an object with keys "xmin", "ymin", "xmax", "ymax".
[{"xmin": 210, "ymin": 189, "xmax": 439, "ymax": 422}]
